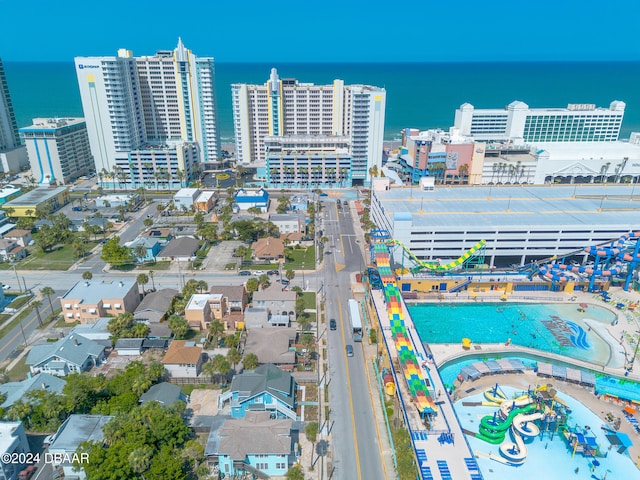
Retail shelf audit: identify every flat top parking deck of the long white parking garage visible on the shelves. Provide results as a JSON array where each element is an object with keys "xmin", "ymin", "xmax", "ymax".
[{"xmin": 376, "ymin": 185, "xmax": 640, "ymax": 229}]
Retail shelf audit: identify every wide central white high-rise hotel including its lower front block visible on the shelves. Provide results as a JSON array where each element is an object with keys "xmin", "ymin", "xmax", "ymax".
[{"xmin": 231, "ymin": 68, "xmax": 386, "ymax": 186}]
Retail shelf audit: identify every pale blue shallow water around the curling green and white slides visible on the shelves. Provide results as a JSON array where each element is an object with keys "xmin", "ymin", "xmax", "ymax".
[{"xmin": 455, "ymin": 387, "xmax": 640, "ymax": 480}]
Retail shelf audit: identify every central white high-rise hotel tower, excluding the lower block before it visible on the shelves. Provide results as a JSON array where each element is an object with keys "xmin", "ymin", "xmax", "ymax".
[{"xmin": 231, "ymin": 68, "xmax": 386, "ymax": 183}]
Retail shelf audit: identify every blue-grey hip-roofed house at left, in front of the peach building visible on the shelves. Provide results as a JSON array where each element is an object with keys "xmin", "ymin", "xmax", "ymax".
[{"xmin": 26, "ymin": 334, "xmax": 105, "ymax": 377}]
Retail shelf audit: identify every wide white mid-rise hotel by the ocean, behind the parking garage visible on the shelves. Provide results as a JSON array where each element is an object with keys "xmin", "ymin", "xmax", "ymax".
[{"xmin": 455, "ymin": 100, "xmax": 626, "ymax": 143}]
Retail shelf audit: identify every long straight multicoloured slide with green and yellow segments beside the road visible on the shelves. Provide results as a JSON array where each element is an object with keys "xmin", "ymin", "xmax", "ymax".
[{"xmin": 373, "ymin": 243, "xmax": 438, "ymax": 413}]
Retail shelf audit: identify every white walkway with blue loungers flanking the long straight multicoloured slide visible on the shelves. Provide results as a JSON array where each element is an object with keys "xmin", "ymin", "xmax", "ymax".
[{"xmin": 371, "ymin": 290, "xmax": 474, "ymax": 480}]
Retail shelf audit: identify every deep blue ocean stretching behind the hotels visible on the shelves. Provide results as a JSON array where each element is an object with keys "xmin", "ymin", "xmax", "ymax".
[{"xmin": 4, "ymin": 62, "xmax": 640, "ymax": 142}]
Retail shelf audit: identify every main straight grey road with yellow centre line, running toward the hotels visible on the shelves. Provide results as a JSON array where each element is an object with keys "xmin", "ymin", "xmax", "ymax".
[{"xmin": 322, "ymin": 201, "xmax": 384, "ymax": 480}]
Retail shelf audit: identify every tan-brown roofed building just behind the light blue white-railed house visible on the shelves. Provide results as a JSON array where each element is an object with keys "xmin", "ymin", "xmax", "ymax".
[{"xmin": 244, "ymin": 327, "xmax": 296, "ymax": 371}]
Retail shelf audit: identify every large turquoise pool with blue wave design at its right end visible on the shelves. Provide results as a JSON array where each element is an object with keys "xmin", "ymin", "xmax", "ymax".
[{"xmin": 407, "ymin": 302, "xmax": 619, "ymax": 366}]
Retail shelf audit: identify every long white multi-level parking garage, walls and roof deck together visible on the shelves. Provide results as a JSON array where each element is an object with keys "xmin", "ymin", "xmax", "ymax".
[{"xmin": 371, "ymin": 185, "xmax": 640, "ymax": 266}]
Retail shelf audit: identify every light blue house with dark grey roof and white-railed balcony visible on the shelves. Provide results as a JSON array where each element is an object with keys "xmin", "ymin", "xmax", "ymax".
[{"xmin": 218, "ymin": 363, "xmax": 298, "ymax": 420}]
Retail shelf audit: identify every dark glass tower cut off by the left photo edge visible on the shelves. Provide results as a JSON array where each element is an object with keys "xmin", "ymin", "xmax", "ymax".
[{"xmin": 0, "ymin": 59, "xmax": 29, "ymax": 173}]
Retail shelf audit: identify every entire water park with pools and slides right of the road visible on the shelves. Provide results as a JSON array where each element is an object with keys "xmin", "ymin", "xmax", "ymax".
[{"xmin": 368, "ymin": 230, "xmax": 640, "ymax": 480}]
